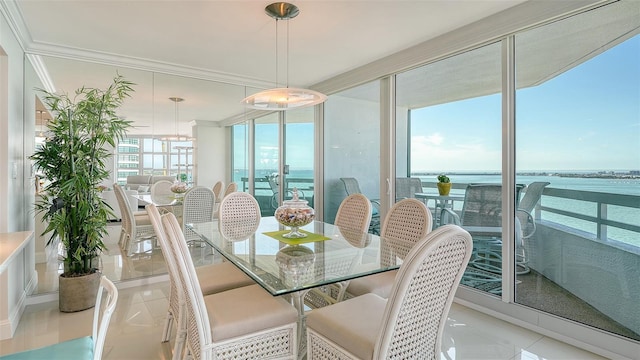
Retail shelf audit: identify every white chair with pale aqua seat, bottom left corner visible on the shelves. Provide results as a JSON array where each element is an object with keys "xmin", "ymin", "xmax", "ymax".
[{"xmin": 0, "ymin": 275, "xmax": 118, "ymax": 360}]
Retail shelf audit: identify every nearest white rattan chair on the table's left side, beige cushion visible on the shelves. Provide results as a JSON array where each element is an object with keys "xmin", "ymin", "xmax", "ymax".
[{"xmin": 162, "ymin": 214, "xmax": 298, "ymax": 360}]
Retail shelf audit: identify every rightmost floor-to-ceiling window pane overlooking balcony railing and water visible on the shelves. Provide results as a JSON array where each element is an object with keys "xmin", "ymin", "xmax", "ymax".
[{"xmin": 515, "ymin": 2, "xmax": 640, "ymax": 340}]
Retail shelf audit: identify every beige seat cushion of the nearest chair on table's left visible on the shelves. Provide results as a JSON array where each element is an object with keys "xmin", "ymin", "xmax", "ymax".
[{"xmin": 204, "ymin": 285, "xmax": 298, "ymax": 342}]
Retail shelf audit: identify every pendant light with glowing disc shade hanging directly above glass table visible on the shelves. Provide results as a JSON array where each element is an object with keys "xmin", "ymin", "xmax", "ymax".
[{"xmin": 242, "ymin": 2, "xmax": 327, "ymax": 111}]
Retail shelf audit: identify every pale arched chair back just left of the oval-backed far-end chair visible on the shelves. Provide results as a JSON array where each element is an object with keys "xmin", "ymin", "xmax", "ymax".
[{"xmin": 182, "ymin": 186, "xmax": 215, "ymax": 241}]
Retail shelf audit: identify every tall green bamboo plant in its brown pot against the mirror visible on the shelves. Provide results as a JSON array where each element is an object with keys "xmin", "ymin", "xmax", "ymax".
[{"xmin": 31, "ymin": 75, "xmax": 133, "ymax": 312}]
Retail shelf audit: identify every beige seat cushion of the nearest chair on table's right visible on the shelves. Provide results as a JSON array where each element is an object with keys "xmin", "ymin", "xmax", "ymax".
[{"xmin": 307, "ymin": 294, "xmax": 387, "ymax": 359}]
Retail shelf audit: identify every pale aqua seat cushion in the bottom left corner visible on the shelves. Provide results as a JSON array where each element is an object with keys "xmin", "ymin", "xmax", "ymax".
[{"xmin": 0, "ymin": 336, "xmax": 93, "ymax": 360}]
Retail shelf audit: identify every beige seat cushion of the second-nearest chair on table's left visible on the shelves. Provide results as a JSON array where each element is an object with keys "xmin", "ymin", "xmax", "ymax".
[{"xmin": 196, "ymin": 262, "xmax": 256, "ymax": 295}]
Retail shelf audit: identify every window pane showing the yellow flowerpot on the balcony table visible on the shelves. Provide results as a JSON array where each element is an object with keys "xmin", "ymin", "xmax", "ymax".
[{"xmin": 396, "ymin": 42, "xmax": 508, "ymax": 295}]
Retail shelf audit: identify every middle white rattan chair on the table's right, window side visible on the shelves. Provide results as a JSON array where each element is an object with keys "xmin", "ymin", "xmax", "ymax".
[{"xmin": 338, "ymin": 199, "xmax": 433, "ymax": 300}]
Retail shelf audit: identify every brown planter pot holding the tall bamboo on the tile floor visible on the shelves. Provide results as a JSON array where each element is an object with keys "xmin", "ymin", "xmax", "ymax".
[{"xmin": 58, "ymin": 272, "xmax": 101, "ymax": 312}]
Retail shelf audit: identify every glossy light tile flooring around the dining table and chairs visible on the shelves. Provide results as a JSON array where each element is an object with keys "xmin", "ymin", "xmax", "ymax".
[{"xmin": 0, "ymin": 226, "xmax": 604, "ymax": 360}]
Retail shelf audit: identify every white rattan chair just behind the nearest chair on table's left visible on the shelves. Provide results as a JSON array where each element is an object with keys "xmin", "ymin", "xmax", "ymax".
[{"xmin": 146, "ymin": 204, "xmax": 255, "ymax": 360}]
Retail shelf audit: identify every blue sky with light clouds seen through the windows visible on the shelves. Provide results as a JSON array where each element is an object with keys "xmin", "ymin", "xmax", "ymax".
[{"xmin": 242, "ymin": 35, "xmax": 640, "ymax": 172}]
